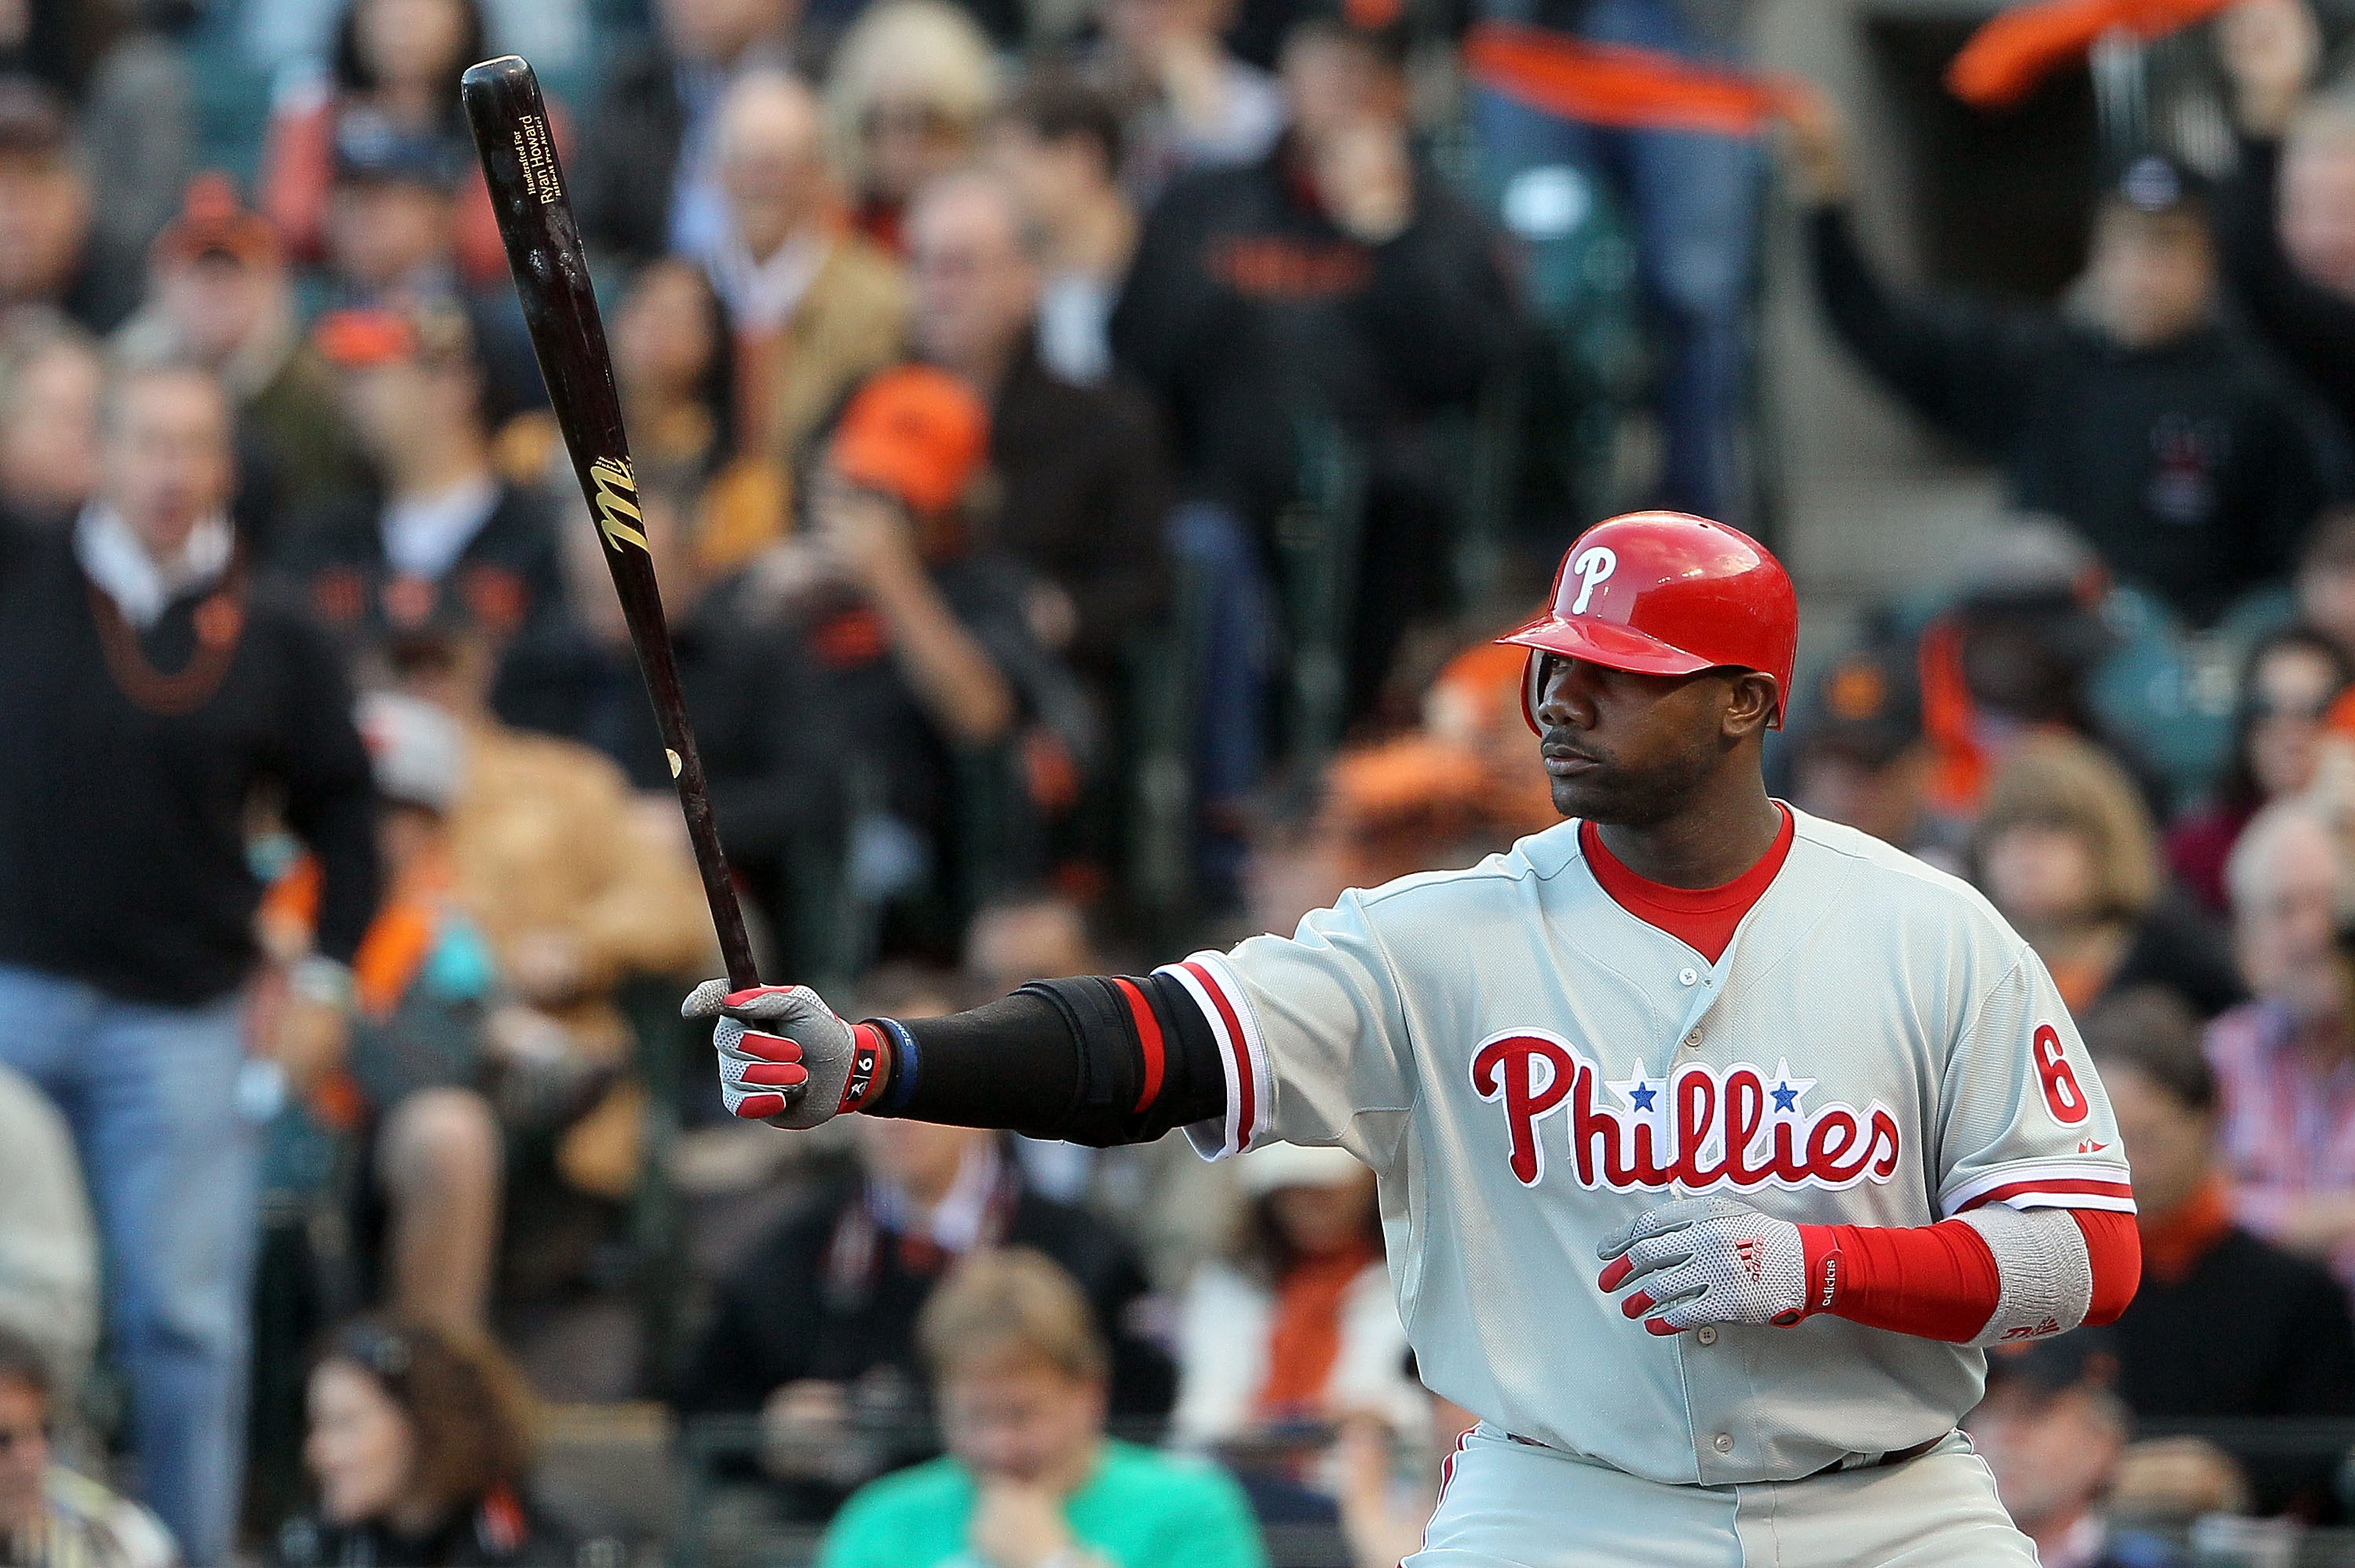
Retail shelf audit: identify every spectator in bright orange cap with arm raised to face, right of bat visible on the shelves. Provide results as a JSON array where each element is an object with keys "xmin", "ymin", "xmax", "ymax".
[{"xmin": 768, "ymin": 365, "xmax": 1086, "ymax": 946}]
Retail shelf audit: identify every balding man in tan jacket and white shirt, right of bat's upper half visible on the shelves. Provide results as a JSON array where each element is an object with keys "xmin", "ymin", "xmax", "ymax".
[{"xmin": 699, "ymin": 71, "xmax": 909, "ymax": 490}]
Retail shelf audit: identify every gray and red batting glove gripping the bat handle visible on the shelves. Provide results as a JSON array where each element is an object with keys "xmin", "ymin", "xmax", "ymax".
[{"xmin": 678, "ymin": 979, "xmax": 890, "ymax": 1128}]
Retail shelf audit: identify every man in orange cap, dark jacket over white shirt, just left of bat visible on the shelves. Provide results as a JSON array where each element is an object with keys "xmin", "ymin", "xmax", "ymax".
[{"xmin": 278, "ymin": 306, "xmax": 563, "ymax": 664}]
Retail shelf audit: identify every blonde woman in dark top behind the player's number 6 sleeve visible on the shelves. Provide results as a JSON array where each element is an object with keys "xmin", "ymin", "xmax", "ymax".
[{"xmin": 1971, "ymin": 735, "xmax": 2242, "ymax": 1017}]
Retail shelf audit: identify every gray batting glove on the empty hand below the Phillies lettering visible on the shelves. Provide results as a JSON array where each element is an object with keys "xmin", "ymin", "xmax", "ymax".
[{"xmin": 1594, "ymin": 1198, "xmax": 1806, "ymax": 1335}]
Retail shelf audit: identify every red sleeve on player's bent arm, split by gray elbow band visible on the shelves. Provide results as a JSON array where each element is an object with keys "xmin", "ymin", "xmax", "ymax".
[{"xmin": 1799, "ymin": 1208, "xmax": 2143, "ymax": 1344}]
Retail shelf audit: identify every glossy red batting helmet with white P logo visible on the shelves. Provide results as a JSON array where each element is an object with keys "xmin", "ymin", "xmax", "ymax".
[{"xmin": 1498, "ymin": 511, "xmax": 1799, "ymax": 730}]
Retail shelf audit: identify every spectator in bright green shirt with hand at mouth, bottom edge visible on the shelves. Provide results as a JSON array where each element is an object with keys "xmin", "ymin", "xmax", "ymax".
[{"xmin": 820, "ymin": 1248, "xmax": 1267, "ymax": 1568}]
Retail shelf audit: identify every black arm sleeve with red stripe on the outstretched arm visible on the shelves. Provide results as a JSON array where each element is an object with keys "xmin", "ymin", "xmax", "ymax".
[{"xmin": 874, "ymin": 975, "xmax": 1227, "ymax": 1149}]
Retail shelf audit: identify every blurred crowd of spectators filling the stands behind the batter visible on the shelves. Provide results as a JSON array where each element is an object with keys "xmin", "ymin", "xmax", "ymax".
[{"xmin": 0, "ymin": 0, "xmax": 2355, "ymax": 1568}]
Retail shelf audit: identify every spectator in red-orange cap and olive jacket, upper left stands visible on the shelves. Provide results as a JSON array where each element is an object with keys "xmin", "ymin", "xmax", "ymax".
[{"xmin": 115, "ymin": 172, "xmax": 367, "ymax": 551}]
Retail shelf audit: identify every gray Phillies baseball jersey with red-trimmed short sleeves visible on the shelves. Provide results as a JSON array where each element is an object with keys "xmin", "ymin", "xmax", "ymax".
[{"xmin": 1166, "ymin": 812, "xmax": 2134, "ymax": 1486}]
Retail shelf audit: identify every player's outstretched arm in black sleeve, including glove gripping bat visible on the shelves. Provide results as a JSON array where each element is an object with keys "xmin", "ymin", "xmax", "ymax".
[{"xmin": 681, "ymin": 975, "xmax": 1229, "ymax": 1144}]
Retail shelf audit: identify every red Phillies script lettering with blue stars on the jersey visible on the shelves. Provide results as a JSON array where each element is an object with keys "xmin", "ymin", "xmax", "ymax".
[{"xmin": 1472, "ymin": 1029, "xmax": 1900, "ymax": 1191}]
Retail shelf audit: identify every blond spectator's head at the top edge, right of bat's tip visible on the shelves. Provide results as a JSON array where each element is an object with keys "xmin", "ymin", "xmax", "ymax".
[{"xmin": 827, "ymin": 0, "xmax": 999, "ymax": 252}]
